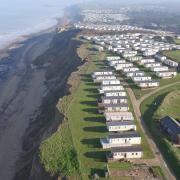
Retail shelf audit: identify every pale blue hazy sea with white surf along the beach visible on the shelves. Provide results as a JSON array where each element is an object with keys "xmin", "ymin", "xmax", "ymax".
[{"xmin": 0, "ymin": 0, "xmax": 80, "ymax": 49}]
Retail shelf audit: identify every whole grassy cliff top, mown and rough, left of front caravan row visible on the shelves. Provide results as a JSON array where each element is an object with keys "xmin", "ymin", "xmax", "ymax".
[{"xmin": 40, "ymin": 37, "xmax": 155, "ymax": 180}]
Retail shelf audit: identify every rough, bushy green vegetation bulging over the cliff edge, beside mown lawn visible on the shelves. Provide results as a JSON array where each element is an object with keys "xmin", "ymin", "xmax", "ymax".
[{"xmin": 39, "ymin": 120, "xmax": 79, "ymax": 177}]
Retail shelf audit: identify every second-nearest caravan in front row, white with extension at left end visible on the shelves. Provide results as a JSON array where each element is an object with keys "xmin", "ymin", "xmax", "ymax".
[{"xmin": 100, "ymin": 131, "xmax": 141, "ymax": 149}]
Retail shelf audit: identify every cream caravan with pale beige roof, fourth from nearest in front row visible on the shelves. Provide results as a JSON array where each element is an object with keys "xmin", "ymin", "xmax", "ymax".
[{"xmin": 104, "ymin": 112, "xmax": 134, "ymax": 121}]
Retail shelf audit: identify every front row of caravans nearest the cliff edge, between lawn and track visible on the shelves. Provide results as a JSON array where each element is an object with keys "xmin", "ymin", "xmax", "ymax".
[{"xmin": 92, "ymin": 64, "xmax": 143, "ymax": 161}]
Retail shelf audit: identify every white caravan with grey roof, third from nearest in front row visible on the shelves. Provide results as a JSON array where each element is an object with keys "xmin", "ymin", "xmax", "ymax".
[{"xmin": 106, "ymin": 121, "xmax": 136, "ymax": 132}]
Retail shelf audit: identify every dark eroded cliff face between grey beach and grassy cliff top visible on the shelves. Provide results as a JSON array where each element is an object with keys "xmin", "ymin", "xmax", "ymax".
[{"xmin": 15, "ymin": 30, "xmax": 83, "ymax": 180}]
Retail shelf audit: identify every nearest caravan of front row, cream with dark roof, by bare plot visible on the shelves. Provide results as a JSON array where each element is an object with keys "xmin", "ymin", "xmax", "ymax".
[{"xmin": 111, "ymin": 146, "xmax": 143, "ymax": 160}]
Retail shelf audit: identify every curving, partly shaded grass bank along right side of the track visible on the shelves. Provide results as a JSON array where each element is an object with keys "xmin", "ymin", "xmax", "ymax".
[{"xmin": 141, "ymin": 85, "xmax": 180, "ymax": 179}]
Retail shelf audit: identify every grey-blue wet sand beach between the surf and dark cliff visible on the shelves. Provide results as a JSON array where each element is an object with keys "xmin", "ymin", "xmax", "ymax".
[{"xmin": 0, "ymin": 30, "xmax": 54, "ymax": 180}]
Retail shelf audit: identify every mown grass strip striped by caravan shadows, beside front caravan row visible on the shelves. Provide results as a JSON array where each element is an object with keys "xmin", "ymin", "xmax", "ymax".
[{"xmin": 67, "ymin": 45, "xmax": 107, "ymax": 179}]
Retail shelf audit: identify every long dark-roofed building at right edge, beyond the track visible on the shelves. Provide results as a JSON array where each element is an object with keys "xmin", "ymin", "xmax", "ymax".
[{"xmin": 160, "ymin": 116, "xmax": 180, "ymax": 144}]
